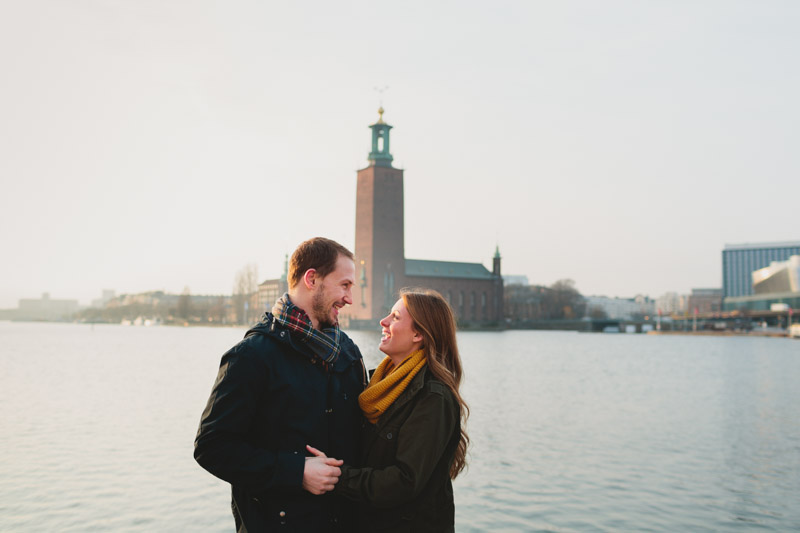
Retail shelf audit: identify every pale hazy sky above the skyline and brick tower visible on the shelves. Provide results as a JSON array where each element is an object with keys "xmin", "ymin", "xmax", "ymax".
[{"xmin": 0, "ymin": 0, "xmax": 800, "ymax": 308}]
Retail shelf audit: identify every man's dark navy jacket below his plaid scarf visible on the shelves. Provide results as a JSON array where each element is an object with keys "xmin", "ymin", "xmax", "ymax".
[{"xmin": 194, "ymin": 313, "xmax": 367, "ymax": 533}]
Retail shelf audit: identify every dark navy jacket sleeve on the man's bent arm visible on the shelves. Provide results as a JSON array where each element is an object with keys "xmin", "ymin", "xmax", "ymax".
[{"xmin": 194, "ymin": 343, "xmax": 305, "ymax": 493}]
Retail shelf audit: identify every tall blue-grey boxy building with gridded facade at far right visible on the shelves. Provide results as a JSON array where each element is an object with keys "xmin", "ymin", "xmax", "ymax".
[{"xmin": 722, "ymin": 241, "xmax": 800, "ymax": 298}]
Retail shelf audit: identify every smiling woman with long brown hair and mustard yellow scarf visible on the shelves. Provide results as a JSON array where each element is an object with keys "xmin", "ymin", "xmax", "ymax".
[{"xmin": 309, "ymin": 289, "xmax": 469, "ymax": 532}]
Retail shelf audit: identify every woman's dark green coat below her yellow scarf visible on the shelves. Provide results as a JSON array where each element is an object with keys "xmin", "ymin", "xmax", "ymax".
[{"xmin": 335, "ymin": 366, "xmax": 461, "ymax": 532}]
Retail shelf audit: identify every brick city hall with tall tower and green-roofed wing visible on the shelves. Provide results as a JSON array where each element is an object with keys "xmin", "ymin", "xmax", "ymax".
[{"xmin": 342, "ymin": 108, "xmax": 503, "ymax": 327}]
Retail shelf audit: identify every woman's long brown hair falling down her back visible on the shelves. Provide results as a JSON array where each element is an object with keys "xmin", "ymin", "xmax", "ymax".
[{"xmin": 400, "ymin": 289, "xmax": 469, "ymax": 479}]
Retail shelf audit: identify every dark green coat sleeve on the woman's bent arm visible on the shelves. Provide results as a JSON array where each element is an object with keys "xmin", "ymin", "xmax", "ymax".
[{"xmin": 335, "ymin": 382, "xmax": 459, "ymax": 508}]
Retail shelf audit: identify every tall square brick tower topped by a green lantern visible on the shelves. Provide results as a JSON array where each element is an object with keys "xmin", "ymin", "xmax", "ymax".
[{"xmin": 349, "ymin": 108, "xmax": 405, "ymax": 320}]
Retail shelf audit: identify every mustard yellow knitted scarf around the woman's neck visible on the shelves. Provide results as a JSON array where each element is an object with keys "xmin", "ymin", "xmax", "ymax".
[{"xmin": 358, "ymin": 350, "xmax": 427, "ymax": 424}]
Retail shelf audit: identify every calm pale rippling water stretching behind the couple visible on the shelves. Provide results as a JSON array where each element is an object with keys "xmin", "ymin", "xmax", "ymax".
[{"xmin": 0, "ymin": 322, "xmax": 800, "ymax": 532}]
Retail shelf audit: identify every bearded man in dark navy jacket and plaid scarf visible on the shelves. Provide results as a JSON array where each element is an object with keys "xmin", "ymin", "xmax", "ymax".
[{"xmin": 194, "ymin": 237, "xmax": 367, "ymax": 533}]
